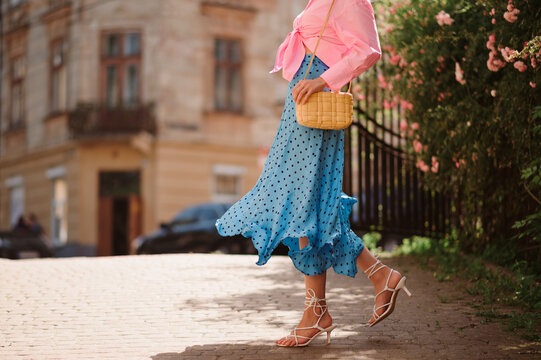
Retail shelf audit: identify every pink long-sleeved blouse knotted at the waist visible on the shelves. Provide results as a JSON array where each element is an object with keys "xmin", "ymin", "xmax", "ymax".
[{"xmin": 270, "ymin": 0, "xmax": 381, "ymax": 91}]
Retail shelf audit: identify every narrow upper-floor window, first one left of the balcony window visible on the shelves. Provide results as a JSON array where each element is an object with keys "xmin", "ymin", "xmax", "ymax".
[{"xmin": 50, "ymin": 39, "xmax": 67, "ymax": 112}]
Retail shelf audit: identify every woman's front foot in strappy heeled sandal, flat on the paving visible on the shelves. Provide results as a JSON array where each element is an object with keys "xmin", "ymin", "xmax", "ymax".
[{"xmin": 275, "ymin": 297, "xmax": 332, "ymax": 346}]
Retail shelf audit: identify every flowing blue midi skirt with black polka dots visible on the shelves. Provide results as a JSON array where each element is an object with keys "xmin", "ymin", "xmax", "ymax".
[{"xmin": 216, "ymin": 55, "xmax": 364, "ymax": 277}]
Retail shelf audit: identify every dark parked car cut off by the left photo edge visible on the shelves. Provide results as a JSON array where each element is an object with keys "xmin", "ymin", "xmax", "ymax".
[{"xmin": 0, "ymin": 231, "xmax": 54, "ymax": 260}]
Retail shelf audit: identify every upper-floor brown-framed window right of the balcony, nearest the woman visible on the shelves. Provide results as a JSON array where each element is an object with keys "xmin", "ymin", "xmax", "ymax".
[{"xmin": 214, "ymin": 38, "xmax": 243, "ymax": 112}]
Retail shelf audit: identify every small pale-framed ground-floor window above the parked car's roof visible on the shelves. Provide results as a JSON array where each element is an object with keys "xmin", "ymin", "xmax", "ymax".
[{"xmin": 212, "ymin": 164, "xmax": 245, "ymax": 203}]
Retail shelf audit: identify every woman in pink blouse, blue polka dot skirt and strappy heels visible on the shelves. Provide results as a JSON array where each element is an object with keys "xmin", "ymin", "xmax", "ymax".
[{"xmin": 216, "ymin": 0, "xmax": 409, "ymax": 346}]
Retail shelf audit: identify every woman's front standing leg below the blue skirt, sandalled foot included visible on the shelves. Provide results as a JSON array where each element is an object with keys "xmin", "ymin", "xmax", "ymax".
[{"xmin": 276, "ymin": 237, "xmax": 332, "ymax": 346}]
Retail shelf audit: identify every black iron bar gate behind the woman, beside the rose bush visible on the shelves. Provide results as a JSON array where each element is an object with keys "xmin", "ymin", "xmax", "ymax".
[{"xmin": 343, "ymin": 58, "xmax": 451, "ymax": 241}]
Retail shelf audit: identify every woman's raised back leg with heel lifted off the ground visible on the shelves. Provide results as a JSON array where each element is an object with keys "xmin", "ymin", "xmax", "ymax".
[{"xmin": 357, "ymin": 247, "xmax": 402, "ymax": 323}]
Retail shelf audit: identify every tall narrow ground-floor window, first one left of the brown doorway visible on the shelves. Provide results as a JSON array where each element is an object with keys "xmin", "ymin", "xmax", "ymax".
[{"xmin": 51, "ymin": 178, "xmax": 68, "ymax": 245}]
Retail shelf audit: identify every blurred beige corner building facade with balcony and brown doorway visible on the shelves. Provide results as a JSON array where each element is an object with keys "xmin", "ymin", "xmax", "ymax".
[{"xmin": 0, "ymin": 0, "xmax": 306, "ymax": 255}]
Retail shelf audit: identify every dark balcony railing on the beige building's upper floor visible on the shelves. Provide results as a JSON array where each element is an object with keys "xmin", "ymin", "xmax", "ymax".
[{"xmin": 68, "ymin": 103, "xmax": 156, "ymax": 138}]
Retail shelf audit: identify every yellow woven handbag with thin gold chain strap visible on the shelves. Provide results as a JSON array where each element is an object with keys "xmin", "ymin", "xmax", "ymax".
[{"xmin": 296, "ymin": 0, "xmax": 353, "ymax": 130}]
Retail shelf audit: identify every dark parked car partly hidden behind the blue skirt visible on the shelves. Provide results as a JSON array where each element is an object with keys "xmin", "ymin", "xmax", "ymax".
[{"xmin": 132, "ymin": 203, "xmax": 287, "ymax": 254}]
